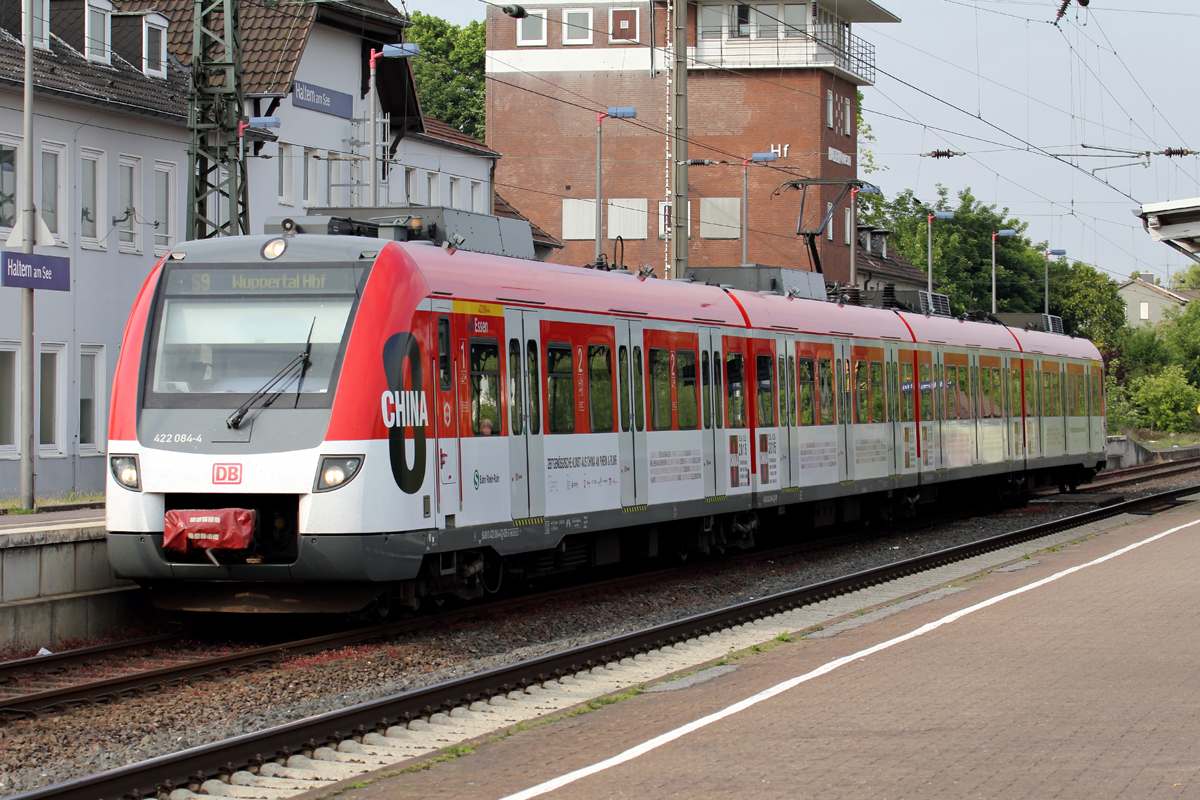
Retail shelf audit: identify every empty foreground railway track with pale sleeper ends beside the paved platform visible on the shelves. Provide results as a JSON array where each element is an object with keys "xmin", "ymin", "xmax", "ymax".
[{"xmin": 17, "ymin": 485, "xmax": 1200, "ymax": 800}]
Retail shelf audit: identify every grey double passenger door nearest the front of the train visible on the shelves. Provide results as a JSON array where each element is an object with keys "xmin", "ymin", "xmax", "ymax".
[{"xmin": 504, "ymin": 308, "xmax": 546, "ymax": 519}]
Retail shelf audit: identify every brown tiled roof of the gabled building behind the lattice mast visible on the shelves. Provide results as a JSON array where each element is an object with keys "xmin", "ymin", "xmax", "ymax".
[{"xmin": 115, "ymin": 0, "xmax": 408, "ymax": 95}]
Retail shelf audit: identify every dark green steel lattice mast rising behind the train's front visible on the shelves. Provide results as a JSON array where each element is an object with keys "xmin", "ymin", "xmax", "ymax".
[{"xmin": 187, "ymin": 0, "xmax": 250, "ymax": 239}]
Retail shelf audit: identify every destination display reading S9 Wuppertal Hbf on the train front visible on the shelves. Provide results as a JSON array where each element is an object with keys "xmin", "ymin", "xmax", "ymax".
[{"xmin": 167, "ymin": 266, "xmax": 361, "ymax": 295}]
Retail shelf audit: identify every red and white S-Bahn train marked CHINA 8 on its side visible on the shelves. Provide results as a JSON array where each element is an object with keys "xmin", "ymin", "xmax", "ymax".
[{"xmin": 107, "ymin": 235, "xmax": 1105, "ymax": 612}]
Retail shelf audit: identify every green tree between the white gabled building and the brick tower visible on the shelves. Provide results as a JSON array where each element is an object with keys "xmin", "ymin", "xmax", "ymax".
[{"xmin": 404, "ymin": 11, "xmax": 487, "ymax": 142}]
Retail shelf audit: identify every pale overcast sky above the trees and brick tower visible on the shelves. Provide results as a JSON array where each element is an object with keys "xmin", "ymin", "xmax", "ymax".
[{"xmin": 394, "ymin": 0, "xmax": 1200, "ymax": 284}]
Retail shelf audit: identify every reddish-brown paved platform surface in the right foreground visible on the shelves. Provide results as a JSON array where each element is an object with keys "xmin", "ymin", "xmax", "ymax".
[{"xmin": 333, "ymin": 504, "xmax": 1200, "ymax": 800}]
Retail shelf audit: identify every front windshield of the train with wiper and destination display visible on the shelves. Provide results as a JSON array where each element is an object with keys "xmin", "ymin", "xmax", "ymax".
[{"xmin": 146, "ymin": 264, "xmax": 365, "ymax": 408}]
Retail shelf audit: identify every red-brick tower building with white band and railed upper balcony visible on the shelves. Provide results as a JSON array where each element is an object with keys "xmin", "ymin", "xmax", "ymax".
[{"xmin": 487, "ymin": 0, "xmax": 900, "ymax": 283}]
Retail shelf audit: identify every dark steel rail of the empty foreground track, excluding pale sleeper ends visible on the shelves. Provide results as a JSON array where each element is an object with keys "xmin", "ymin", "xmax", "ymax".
[{"xmin": 12, "ymin": 485, "xmax": 1200, "ymax": 800}]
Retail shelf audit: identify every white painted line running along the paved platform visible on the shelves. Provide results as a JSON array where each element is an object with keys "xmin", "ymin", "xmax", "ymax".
[{"xmin": 503, "ymin": 519, "xmax": 1200, "ymax": 800}]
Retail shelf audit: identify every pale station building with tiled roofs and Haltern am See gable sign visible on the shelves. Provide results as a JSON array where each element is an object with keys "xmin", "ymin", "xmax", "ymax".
[{"xmin": 0, "ymin": 0, "xmax": 535, "ymax": 500}]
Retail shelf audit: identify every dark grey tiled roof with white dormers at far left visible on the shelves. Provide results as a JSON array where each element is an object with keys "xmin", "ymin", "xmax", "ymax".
[{"xmin": 0, "ymin": 29, "xmax": 187, "ymax": 125}]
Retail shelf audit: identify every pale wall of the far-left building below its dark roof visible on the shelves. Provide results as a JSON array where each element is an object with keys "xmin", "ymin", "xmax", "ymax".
[{"xmin": 0, "ymin": 92, "xmax": 188, "ymax": 500}]
